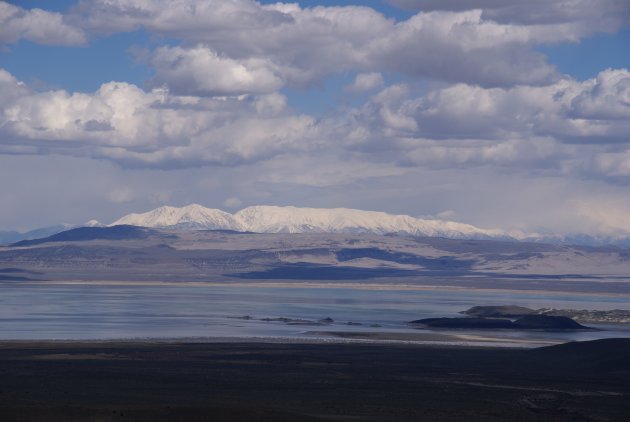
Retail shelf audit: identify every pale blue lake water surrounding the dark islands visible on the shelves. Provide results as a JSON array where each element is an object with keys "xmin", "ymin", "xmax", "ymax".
[{"xmin": 0, "ymin": 283, "xmax": 630, "ymax": 344}]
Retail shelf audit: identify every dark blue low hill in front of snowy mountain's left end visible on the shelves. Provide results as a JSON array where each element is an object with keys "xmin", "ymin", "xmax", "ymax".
[{"xmin": 11, "ymin": 225, "xmax": 157, "ymax": 246}]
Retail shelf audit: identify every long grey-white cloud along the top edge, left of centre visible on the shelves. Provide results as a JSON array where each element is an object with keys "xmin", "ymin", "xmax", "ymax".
[{"xmin": 70, "ymin": 0, "xmax": 393, "ymax": 85}]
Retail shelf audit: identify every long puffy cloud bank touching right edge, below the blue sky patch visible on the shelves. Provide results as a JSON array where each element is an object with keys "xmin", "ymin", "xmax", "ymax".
[{"xmin": 346, "ymin": 69, "xmax": 630, "ymax": 147}]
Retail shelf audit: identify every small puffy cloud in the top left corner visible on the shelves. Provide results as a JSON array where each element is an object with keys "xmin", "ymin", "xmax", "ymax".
[{"xmin": 0, "ymin": 1, "xmax": 86, "ymax": 45}]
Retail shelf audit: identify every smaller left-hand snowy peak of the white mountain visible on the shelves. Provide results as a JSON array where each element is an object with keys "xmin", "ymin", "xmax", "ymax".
[{"xmin": 110, "ymin": 204, "xmax": 244, "ymax": 231}]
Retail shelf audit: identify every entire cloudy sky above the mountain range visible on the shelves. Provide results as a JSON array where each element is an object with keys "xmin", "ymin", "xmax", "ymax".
[{"xmin": 0, "ymin": 0, "xmax": 630, "ymax": 236}]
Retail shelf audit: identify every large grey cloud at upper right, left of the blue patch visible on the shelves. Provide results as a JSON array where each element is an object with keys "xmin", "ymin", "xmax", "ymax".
[{"xmin": 368, "ymin": 10, "xmax": 573, "ymax": 86}]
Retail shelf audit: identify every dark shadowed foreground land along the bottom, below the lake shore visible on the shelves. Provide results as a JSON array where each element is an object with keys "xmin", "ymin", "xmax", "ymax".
[{"xmin": 0, "ymin": 339, "xmax": 630, "ymax": 422}]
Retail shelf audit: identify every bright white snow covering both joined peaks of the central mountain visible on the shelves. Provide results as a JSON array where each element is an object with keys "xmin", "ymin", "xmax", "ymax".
[{"xmin": 111, "ymin": 204, "xmax": 512, "ymax": 239}]
